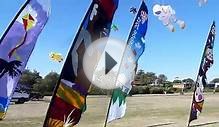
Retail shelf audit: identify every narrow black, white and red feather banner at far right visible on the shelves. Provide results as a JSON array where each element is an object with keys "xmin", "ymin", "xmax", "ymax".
[{"xmin": 188, "ymin": 22, "xmax": 216, "ymax": 126}]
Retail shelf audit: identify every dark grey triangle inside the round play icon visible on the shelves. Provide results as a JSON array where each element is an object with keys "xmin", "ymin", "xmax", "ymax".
[{"xmin": 105, "ymin": 52, "xmax": 117, "ymax": 74}]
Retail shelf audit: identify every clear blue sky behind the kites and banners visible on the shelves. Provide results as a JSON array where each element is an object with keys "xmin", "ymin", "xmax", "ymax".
[{"xmin": 0, "ymin": 0, "xmax": 219, "ymax": 81}]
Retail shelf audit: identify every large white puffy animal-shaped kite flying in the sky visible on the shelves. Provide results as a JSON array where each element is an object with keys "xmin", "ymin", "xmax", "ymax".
[{"xmin": 153, "ymin": 4, "xmax": 186, "ymax": 32}]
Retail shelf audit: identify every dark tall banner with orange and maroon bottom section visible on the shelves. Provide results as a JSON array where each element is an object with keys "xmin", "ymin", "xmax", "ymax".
[{"xmin": 44, "ymin": 0, "xmax": 118, "ymax": 127}]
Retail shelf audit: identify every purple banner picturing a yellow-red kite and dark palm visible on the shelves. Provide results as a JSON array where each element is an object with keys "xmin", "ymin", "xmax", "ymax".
[{"xmin": 0, "ymin": 0, "xmax": 50, "ymax": 119}]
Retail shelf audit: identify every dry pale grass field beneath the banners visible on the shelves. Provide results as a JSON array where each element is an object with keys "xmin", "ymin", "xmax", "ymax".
[{"xmin": 0, "ymin": 93, "xmax": 219, "ymax": 127}]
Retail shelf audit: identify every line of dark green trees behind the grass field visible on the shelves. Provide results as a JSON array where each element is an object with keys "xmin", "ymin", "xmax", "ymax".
[{"xmin": 18, "ymin": 69, "xmax": 219, "ymax": 95}]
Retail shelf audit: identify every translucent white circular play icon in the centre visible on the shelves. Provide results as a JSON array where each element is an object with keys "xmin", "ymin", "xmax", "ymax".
[{"xmin": 83, "ymin": 38, "xmax": 135, "ymax": 89}]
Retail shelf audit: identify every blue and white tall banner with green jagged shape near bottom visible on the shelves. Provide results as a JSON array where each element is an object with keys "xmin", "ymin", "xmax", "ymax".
[{"xmin": 107, "ymin": 1, "xmax": 148, "ymax": 122}]
